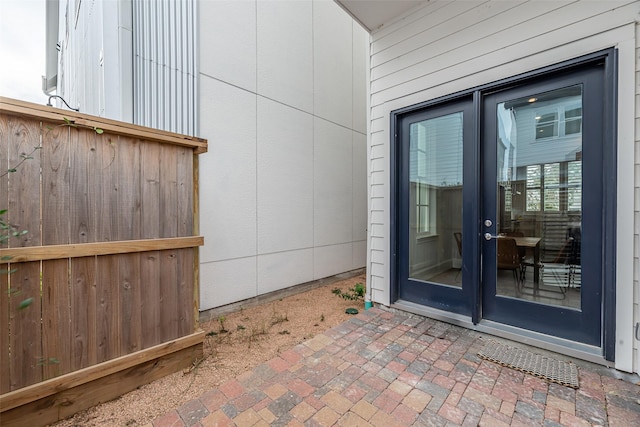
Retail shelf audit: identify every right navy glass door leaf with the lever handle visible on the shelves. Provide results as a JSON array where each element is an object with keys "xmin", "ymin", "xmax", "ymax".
[{"xmin": 481, "ymin": 62, "xmax": 605, "ymax": 345}]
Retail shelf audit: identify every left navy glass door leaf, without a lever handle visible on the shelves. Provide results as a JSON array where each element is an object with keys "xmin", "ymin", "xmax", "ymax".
[{"xmin": 394, "ymin": 97, "xmax": 477, "ymax": 314}]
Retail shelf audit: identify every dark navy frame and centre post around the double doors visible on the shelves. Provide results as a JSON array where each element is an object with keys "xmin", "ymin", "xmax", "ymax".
[{"xmin": 390, "ymin": 48, "xmax": 617, "ymax": 361}]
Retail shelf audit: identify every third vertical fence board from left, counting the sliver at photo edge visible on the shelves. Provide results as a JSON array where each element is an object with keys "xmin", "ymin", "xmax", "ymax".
[{"xmin": 41, "ymin": 122, "xmax": 71, "ymax": 379}]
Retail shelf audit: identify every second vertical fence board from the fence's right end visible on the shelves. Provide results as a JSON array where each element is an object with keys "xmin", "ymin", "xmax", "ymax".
[{"xmin": 159, "ymin": 145, "xmax": 179, "ymax": 341}]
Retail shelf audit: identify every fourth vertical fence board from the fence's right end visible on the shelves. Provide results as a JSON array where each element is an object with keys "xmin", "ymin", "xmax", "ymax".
[{"xmin": 117, "ymin": 137, "xmax": 142, "ymax": 355}]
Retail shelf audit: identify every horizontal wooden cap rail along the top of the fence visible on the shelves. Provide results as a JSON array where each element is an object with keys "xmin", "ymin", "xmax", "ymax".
[{"xmin": 0, "ymin": 97, "xmax": 207, "ymax": 154}]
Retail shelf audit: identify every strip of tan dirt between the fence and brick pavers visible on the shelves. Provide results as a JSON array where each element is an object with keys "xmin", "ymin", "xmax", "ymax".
[{"xmin": 53, "ymin": 275, "xmax": 365, "ymax": 427}]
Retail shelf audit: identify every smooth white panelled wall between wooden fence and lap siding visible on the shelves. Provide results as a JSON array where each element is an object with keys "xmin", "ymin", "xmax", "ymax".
[{"xmin": 198, "ymin": 0, "xmax": 368, "ymax": 310}]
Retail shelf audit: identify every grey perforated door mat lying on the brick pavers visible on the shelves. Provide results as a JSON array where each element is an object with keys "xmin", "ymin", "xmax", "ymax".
[{"xmin": 478, "ymin": 341, "xmax": 580, "ymax": 389}]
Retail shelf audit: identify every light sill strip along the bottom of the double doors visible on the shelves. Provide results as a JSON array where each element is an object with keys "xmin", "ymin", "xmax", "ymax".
[{"xmin": 391, "ymin": 300, "xmax": 615, "ymax": 368}]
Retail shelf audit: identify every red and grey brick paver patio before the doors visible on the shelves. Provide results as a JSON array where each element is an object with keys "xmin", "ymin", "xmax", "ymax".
[{"xmin": 152, "ymin": 308, "xmax": 640, "ymax": 427}]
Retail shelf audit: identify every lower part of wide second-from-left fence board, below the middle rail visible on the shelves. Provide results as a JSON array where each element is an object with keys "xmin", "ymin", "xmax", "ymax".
[{"xmin": 9, "ymin": 262, "xmax": 42, "ymax": 390}]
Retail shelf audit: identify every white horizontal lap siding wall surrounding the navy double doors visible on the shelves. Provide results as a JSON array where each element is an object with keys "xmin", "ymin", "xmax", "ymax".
[{"xmin": 367, "ymin": 0, "xmax": 640, "ymax": 371}]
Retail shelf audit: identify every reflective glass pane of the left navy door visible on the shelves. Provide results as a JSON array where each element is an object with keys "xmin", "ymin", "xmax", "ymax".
[{"xmin": 408, "ymin": 112, "xmax": 463, "ymax": 287}]
